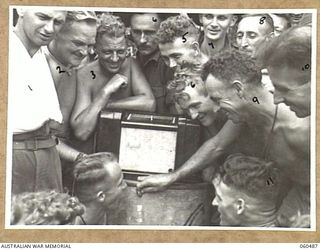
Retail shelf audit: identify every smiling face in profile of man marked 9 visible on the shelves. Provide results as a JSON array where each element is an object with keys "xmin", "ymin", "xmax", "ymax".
[{"xmin": 205, "ymin": 74, "xmax": 246, "ymax": 123}]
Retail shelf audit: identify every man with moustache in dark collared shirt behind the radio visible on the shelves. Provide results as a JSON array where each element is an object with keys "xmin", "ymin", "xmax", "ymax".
[{"xmin": 131, "ymin": 13, "xmax": 175, "ymax": 113}]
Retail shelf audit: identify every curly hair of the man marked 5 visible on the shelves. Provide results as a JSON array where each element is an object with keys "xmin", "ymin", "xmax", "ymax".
[{"xmin": 157, "ymin": 15, "xmax": 200, "ymax": 44}]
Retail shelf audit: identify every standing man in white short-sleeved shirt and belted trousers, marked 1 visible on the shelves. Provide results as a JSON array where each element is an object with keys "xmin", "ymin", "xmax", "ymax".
[{"xmin": 8, "ymin": 9, "xmax": 66, "ymax": 194}]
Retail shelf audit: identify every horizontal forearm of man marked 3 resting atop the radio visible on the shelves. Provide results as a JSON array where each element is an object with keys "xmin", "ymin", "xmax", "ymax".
[{"xmin": 107, "ymin": 95, "xmax": 156, "ymax": 112}]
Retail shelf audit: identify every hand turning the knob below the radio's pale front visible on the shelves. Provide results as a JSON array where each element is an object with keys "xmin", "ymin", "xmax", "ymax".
[{"xmin": 137, "ymin": 174, "xmax": 174, "ymax": 196}]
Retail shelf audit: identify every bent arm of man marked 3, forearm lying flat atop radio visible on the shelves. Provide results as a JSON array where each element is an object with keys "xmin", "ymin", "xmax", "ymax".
[{"xmin": 107, "ymin": 60, "xmax": 156, "ymax": 112}]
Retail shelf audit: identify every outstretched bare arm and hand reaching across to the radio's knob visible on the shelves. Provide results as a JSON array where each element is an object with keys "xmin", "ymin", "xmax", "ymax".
[{"xmin": 137, "ymin": 120, "xmax": 242, "ymax": 194}]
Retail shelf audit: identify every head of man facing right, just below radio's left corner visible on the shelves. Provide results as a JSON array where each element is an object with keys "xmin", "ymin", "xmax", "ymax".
[{"xmin": 74, "ymin": 153, "xmax": 127, "ymax": 209}]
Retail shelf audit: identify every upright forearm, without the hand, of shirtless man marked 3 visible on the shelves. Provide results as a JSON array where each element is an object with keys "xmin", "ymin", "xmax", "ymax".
[{"xmin": 71, "ymin": 91, "xmax": 110, "ymax": 140}]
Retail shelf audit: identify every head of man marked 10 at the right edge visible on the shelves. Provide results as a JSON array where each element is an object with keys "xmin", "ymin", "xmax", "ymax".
[{"xmin": 258, "ymin": 26, "xmax": 311, "ymax": 117}]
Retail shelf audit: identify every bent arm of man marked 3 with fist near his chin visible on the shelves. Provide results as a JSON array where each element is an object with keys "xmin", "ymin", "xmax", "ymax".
[{"xmin": 70, "ymin": 74, "xmax": 127, "ymax": 140}]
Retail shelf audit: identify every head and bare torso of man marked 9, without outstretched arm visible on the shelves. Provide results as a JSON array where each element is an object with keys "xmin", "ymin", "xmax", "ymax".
[{"xmin": 204, "ymin": 51, "xmax": 310, "ymax": 216}]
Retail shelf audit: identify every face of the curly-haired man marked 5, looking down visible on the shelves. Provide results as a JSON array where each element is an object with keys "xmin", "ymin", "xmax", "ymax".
[{"xmin": 159, "ymin": 38, "xmax": 199, "ymax": 68}]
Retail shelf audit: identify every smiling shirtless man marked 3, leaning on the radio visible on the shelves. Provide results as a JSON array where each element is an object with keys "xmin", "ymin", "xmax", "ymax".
[{"xmin": 71, "ymin": 15, "xmax": 155, "ymax": 140}]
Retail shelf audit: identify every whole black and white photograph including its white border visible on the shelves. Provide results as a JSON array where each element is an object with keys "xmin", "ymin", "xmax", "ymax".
[{"xmin": 5, "ymin": 6, "xmax": 317, "ymax": 231}]
